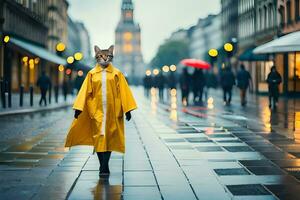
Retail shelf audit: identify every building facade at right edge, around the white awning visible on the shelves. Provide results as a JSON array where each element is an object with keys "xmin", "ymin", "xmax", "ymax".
[{"xmin": 238, "ymin": 0, "xmax": 300, "ymax": 95}]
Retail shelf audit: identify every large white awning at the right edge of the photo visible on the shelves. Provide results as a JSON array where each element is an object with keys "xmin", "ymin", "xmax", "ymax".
[{"xmin": 253, "ymin": 31, "xmax": 300, "ymax": 54}]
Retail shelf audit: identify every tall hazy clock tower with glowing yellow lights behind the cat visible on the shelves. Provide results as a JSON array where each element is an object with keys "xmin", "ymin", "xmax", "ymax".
[{"xmin": 114, "ymin": 0, "xmax": 145, "ymax": 84}]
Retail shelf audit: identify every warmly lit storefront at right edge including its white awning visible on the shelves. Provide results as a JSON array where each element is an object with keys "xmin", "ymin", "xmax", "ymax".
[{"xmin": 253, "ymin": 31, "xmax": 300, "ymax": 96}]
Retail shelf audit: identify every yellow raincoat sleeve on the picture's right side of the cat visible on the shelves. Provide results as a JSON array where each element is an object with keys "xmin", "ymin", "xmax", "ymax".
[{"xmin": 120, "ymin": 73, "xmax": 137, "ymax": 113}]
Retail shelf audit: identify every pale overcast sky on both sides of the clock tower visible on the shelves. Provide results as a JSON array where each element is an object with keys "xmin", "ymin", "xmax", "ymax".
[{"xmin": 69, "ymin": 0, "xmax": 220, "ymax": 62}]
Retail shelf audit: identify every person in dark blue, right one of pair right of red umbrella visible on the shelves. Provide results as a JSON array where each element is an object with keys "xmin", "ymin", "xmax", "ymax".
[{"xmin": 236, "ymin": 64, "xmax": 252, "ymax": 106}]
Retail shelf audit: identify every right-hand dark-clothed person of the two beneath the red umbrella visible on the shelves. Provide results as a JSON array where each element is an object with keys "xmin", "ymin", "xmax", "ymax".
[{"xmin": 192, "ymin": 69, "xmax": 205, "ymax": 104}]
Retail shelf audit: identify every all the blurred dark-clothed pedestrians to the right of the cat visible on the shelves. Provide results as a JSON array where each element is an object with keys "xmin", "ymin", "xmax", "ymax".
[{"xmin": 143, "ymin": 64, "xmax": 282, "ymax": 109}]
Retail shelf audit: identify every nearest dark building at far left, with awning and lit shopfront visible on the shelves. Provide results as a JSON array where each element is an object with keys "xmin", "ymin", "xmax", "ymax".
[{"xmin": 0, "ymin": 0, "xmax": 68, "ymax": 95}]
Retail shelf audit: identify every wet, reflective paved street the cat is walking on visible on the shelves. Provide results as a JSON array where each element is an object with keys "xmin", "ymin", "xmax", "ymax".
[{"xmin": 0, "ymin": 88, "xmax": 300, "ymax": 200}]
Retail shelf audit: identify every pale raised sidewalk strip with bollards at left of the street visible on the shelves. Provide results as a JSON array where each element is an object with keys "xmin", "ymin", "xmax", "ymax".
[{"xmin": 0, "ymin": 93, "xmax": 74, "ymax": 116}]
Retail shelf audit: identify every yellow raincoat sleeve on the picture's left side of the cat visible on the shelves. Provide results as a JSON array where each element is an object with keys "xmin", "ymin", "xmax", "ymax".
[{"xmin": 73, "ymin": 73, "xmax": 92, "ymax": 111}]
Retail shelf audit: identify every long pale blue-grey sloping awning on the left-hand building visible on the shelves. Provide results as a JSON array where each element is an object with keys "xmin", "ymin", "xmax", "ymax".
[{"xmin": 9, "ymin": 37, "xmax": 67, "ymax": 65}]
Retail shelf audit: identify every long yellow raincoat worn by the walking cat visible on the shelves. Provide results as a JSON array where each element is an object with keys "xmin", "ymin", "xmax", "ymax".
[{"xmin": 65, "ymin": 64, "xmax": 137, "ymax": 153}]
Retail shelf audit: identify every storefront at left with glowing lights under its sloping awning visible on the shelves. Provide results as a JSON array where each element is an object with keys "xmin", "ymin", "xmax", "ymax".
[{"xmin": 4, "ymin": 37, "xmax": 66, "ymax": 92}]
